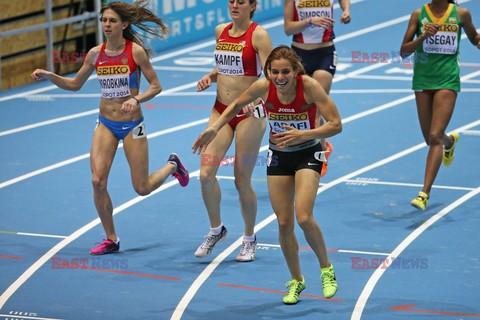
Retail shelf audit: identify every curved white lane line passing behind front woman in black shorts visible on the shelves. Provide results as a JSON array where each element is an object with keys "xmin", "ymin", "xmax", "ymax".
[{"xmin": 170, "ymin": 120, "xmax": 480, "ymax": 320}]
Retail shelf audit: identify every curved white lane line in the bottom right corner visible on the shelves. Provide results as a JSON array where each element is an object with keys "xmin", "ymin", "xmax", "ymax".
[{"xmin": 350, "ymin": 187, "xmax": 480, "ymax": 320}]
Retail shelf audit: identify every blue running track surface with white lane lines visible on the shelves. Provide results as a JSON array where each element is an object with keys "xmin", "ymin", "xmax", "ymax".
[{"xmin": 0, "ymin": 0, "xmax": 480, "ymax": 320}]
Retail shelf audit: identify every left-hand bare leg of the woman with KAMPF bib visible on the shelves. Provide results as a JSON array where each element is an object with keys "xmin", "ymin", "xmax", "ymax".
[{"xmin": 200, "ymin": 109, "xmax": 234, "ymax": 228}]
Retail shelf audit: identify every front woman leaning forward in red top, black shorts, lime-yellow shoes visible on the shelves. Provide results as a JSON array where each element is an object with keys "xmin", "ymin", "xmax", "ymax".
[{"xmin": 192, "ymin": 46, "xmax": 342, "ymax": 304}]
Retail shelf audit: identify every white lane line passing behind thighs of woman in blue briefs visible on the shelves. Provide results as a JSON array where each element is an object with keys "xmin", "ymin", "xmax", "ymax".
[{"xmin": 0, "ymin": 118, "xmax": 208, "ymax": 189}]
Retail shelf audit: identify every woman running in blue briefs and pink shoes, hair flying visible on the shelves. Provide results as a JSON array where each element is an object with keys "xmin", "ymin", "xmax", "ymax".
[{"xmin": 32, "ymin": 0, "xmax": 189, "ymax": 255}]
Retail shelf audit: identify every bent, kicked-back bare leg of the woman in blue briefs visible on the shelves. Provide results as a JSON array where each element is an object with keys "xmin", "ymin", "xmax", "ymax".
[{"xmin": 123, "ymin": 130, "xmax": 176, "ymax": 196}]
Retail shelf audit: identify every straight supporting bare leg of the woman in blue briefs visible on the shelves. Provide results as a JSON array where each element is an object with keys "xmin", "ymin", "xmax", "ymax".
[{"xmin": 90, "ymin": 124, "xmax": 118, "ymax": 241}]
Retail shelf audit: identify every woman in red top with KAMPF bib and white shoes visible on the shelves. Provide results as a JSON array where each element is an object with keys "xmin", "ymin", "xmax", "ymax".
[{"xmin": 195, "ymin": 0, "xmax": 272, "ymax": 262}]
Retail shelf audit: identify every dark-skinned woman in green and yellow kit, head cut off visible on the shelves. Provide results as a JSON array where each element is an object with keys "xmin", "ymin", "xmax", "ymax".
[{"xmin": 400, "ymin": 0, "xmax": 480, "ymax": 210}]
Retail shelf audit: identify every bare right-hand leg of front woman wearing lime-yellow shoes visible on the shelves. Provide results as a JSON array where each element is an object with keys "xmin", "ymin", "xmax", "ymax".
[{"xmin": 295, "ymin": 169, "xmax": 330, "ymax": 268}]
